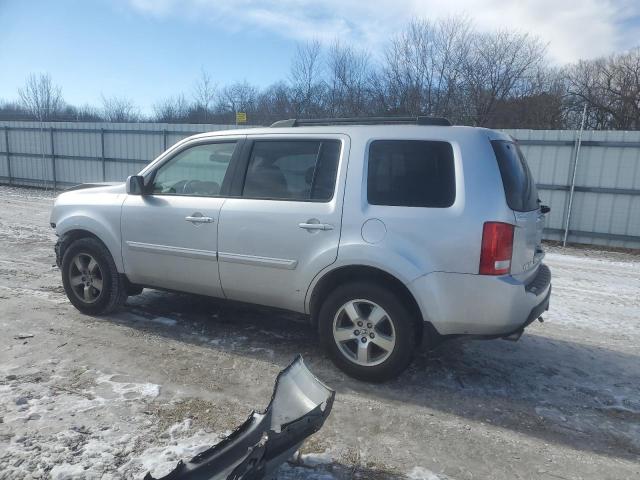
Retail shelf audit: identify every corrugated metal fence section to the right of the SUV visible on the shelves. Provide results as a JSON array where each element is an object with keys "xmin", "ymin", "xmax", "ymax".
[{"xmin": 508, "ymin": 130, "xmax": 640, "ymax": 248}]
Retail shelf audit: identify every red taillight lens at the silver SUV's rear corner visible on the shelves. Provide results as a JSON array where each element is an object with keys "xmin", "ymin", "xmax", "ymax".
[{"xmin": 480, "ymin": 222, "xmax": 513, "ymax": 275}]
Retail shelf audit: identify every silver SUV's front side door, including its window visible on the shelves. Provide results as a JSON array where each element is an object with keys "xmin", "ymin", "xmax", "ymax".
[{"xmin": 121, "ymin": 139, "xmax": 240, "ymax": 297}]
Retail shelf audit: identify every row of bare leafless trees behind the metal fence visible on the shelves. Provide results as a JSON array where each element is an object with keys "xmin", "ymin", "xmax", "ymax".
[{"xmin": 7, "ymin": 17, "xmax": 640, "ymax": 129}]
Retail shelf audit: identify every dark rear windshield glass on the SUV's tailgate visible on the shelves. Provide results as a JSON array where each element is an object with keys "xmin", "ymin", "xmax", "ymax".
[{"xmin": 491, "ymin": 140, "xmax": 538, "ymax": 212}]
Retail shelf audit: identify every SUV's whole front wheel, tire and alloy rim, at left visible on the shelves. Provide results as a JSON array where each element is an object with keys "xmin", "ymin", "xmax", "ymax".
[{"xmin": 62, "ymin": 238, "xmax": 127, "ymax": 315}]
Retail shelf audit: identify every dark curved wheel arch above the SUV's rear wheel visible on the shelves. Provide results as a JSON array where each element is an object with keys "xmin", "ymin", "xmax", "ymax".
[{"xmin": 308, "ymin": 265, "xmax": 425, "ymax": 345}]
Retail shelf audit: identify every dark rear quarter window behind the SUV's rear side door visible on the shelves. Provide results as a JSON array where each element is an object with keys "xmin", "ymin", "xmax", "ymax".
[{"xmin": 367, "ymin": 140, "xmax": 456, "ymax": 208}]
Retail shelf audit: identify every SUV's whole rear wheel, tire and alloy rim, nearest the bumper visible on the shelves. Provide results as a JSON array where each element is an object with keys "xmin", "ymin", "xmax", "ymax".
[{"xmin": 318, "ymin": 282, "xmax": 416, "ymax": 382}]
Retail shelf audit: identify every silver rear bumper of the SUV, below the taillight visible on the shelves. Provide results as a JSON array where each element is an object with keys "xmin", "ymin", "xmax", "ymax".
[{"xmin": 410, "ymin": 264, "xmax": 551, "ymax": 337}]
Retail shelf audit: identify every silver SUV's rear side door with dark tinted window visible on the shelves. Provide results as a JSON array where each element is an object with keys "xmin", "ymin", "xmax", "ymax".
[{"xmin": 218, "ymin": 134, "xmax": 349, "ymax": 311}]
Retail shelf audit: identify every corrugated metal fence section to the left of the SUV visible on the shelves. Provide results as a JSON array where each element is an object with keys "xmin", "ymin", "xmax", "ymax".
[{"xmin": 0, "ymin": 122, "xmax": 235, "ymax": 188}]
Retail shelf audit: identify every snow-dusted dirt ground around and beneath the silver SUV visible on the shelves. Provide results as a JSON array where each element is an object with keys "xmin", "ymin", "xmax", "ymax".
[{"xmin": 0, "ymin": 187, "xmax": 640, "ymax": 480}]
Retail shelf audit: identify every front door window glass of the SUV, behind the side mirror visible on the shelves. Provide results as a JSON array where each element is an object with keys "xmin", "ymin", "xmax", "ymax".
[{"xmin": 152, "ymin": 142, "xmax": 236, "ymax": 197}]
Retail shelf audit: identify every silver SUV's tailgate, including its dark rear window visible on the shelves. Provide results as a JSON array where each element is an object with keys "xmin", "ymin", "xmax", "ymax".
[{"xmin": 491, "ymin": 140, "xmax": 544, "ymax": 280}]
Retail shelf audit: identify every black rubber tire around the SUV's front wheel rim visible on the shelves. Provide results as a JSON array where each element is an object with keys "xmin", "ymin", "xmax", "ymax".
[{"xmin": 61, "ymin": 237, "xmax": 127, "ymax": 315}]
